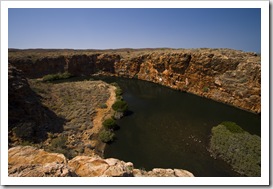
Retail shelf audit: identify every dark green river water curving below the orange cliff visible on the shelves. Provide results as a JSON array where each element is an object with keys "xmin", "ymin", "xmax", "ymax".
[{"xmin": 65, "ymin": 78, "xmax": 261, "ymax": 177}]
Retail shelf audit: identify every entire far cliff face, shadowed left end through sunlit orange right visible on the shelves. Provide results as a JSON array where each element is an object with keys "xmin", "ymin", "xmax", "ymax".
[{"xmin": 9, "ymin": 49, "xmax": 261, "ymax": 113}]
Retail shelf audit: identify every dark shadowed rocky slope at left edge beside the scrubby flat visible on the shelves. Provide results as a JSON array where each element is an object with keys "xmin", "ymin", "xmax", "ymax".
[{"xmin": 8, "ymin": 64, "xmax": 63, "ymax": 144}]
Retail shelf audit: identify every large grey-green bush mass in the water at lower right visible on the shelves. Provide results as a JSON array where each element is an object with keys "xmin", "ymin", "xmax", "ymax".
[{"xmin": 209, "ymin": 122, "xmax": 261, "ymax": 177}]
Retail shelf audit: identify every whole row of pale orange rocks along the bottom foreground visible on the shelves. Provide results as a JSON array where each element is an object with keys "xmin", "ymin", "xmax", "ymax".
[{"xmin": 8, "ymin": 146, "xmax": 193, "ymax": 177}]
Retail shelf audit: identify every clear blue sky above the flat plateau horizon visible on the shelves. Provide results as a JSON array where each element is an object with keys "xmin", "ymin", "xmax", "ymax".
[{"xmin": 8, "ymin": 8, "xmax": 261, "ymax": 52}]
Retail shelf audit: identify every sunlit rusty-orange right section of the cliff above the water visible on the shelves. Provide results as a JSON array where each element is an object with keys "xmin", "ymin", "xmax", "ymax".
[{"xmin": 115, "ymin": 50, "xmax": 261, "ymax": 113}]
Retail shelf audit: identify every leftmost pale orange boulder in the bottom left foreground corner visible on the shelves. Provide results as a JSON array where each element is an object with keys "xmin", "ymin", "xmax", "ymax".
[{"xmin": 8, "ymin": 146, "xmax": 75, "ymax": 177}]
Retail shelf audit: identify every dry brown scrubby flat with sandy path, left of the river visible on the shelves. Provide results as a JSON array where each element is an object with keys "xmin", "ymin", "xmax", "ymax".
[{"xmin": 30, "ymin": 80, "xmax": 116, "ymax": 157}]
